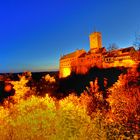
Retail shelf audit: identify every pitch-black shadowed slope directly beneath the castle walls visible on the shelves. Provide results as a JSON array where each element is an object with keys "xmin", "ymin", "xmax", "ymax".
[{"xmin": 58, "ymin": 67, "xmax": 126, "ymax": 95}]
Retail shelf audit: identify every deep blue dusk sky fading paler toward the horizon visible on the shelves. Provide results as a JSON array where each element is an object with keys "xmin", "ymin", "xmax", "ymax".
[{"xmin": 0, "ymin": 0, "xmax": 140, "ymax": 73}]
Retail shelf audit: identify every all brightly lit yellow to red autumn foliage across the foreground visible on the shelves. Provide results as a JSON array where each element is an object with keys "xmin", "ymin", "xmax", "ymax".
[{"xmin": 0, "ymin": 67, "xmax": 140, "ymax": 140}]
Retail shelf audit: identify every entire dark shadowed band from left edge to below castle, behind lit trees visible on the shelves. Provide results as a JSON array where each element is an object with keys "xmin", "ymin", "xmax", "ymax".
[{"xmin": 0, "ymin": 67, "xmax": 126, "ymax": 100}]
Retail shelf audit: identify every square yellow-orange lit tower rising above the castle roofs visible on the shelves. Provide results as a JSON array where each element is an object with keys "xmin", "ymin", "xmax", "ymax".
[{"xmin": 89, "ymin": 32, "xmax": 102, "ymax": 50}]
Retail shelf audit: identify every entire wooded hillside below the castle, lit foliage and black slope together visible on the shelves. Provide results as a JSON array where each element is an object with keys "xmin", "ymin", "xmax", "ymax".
[{"xmin": 0, "ymin": 66, "xmax": 140, "ymax": 140}]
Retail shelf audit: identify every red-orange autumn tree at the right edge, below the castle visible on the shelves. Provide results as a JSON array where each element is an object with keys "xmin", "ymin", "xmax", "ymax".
[{"xmin": 107, "ymin": 68, "xmax": 140, "ymax": 123}]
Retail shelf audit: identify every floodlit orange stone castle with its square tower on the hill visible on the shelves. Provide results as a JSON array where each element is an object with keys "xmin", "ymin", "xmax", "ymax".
[{"xmin": 59, "ymin": 32, "xmax": 137, "ymax": 78}]
